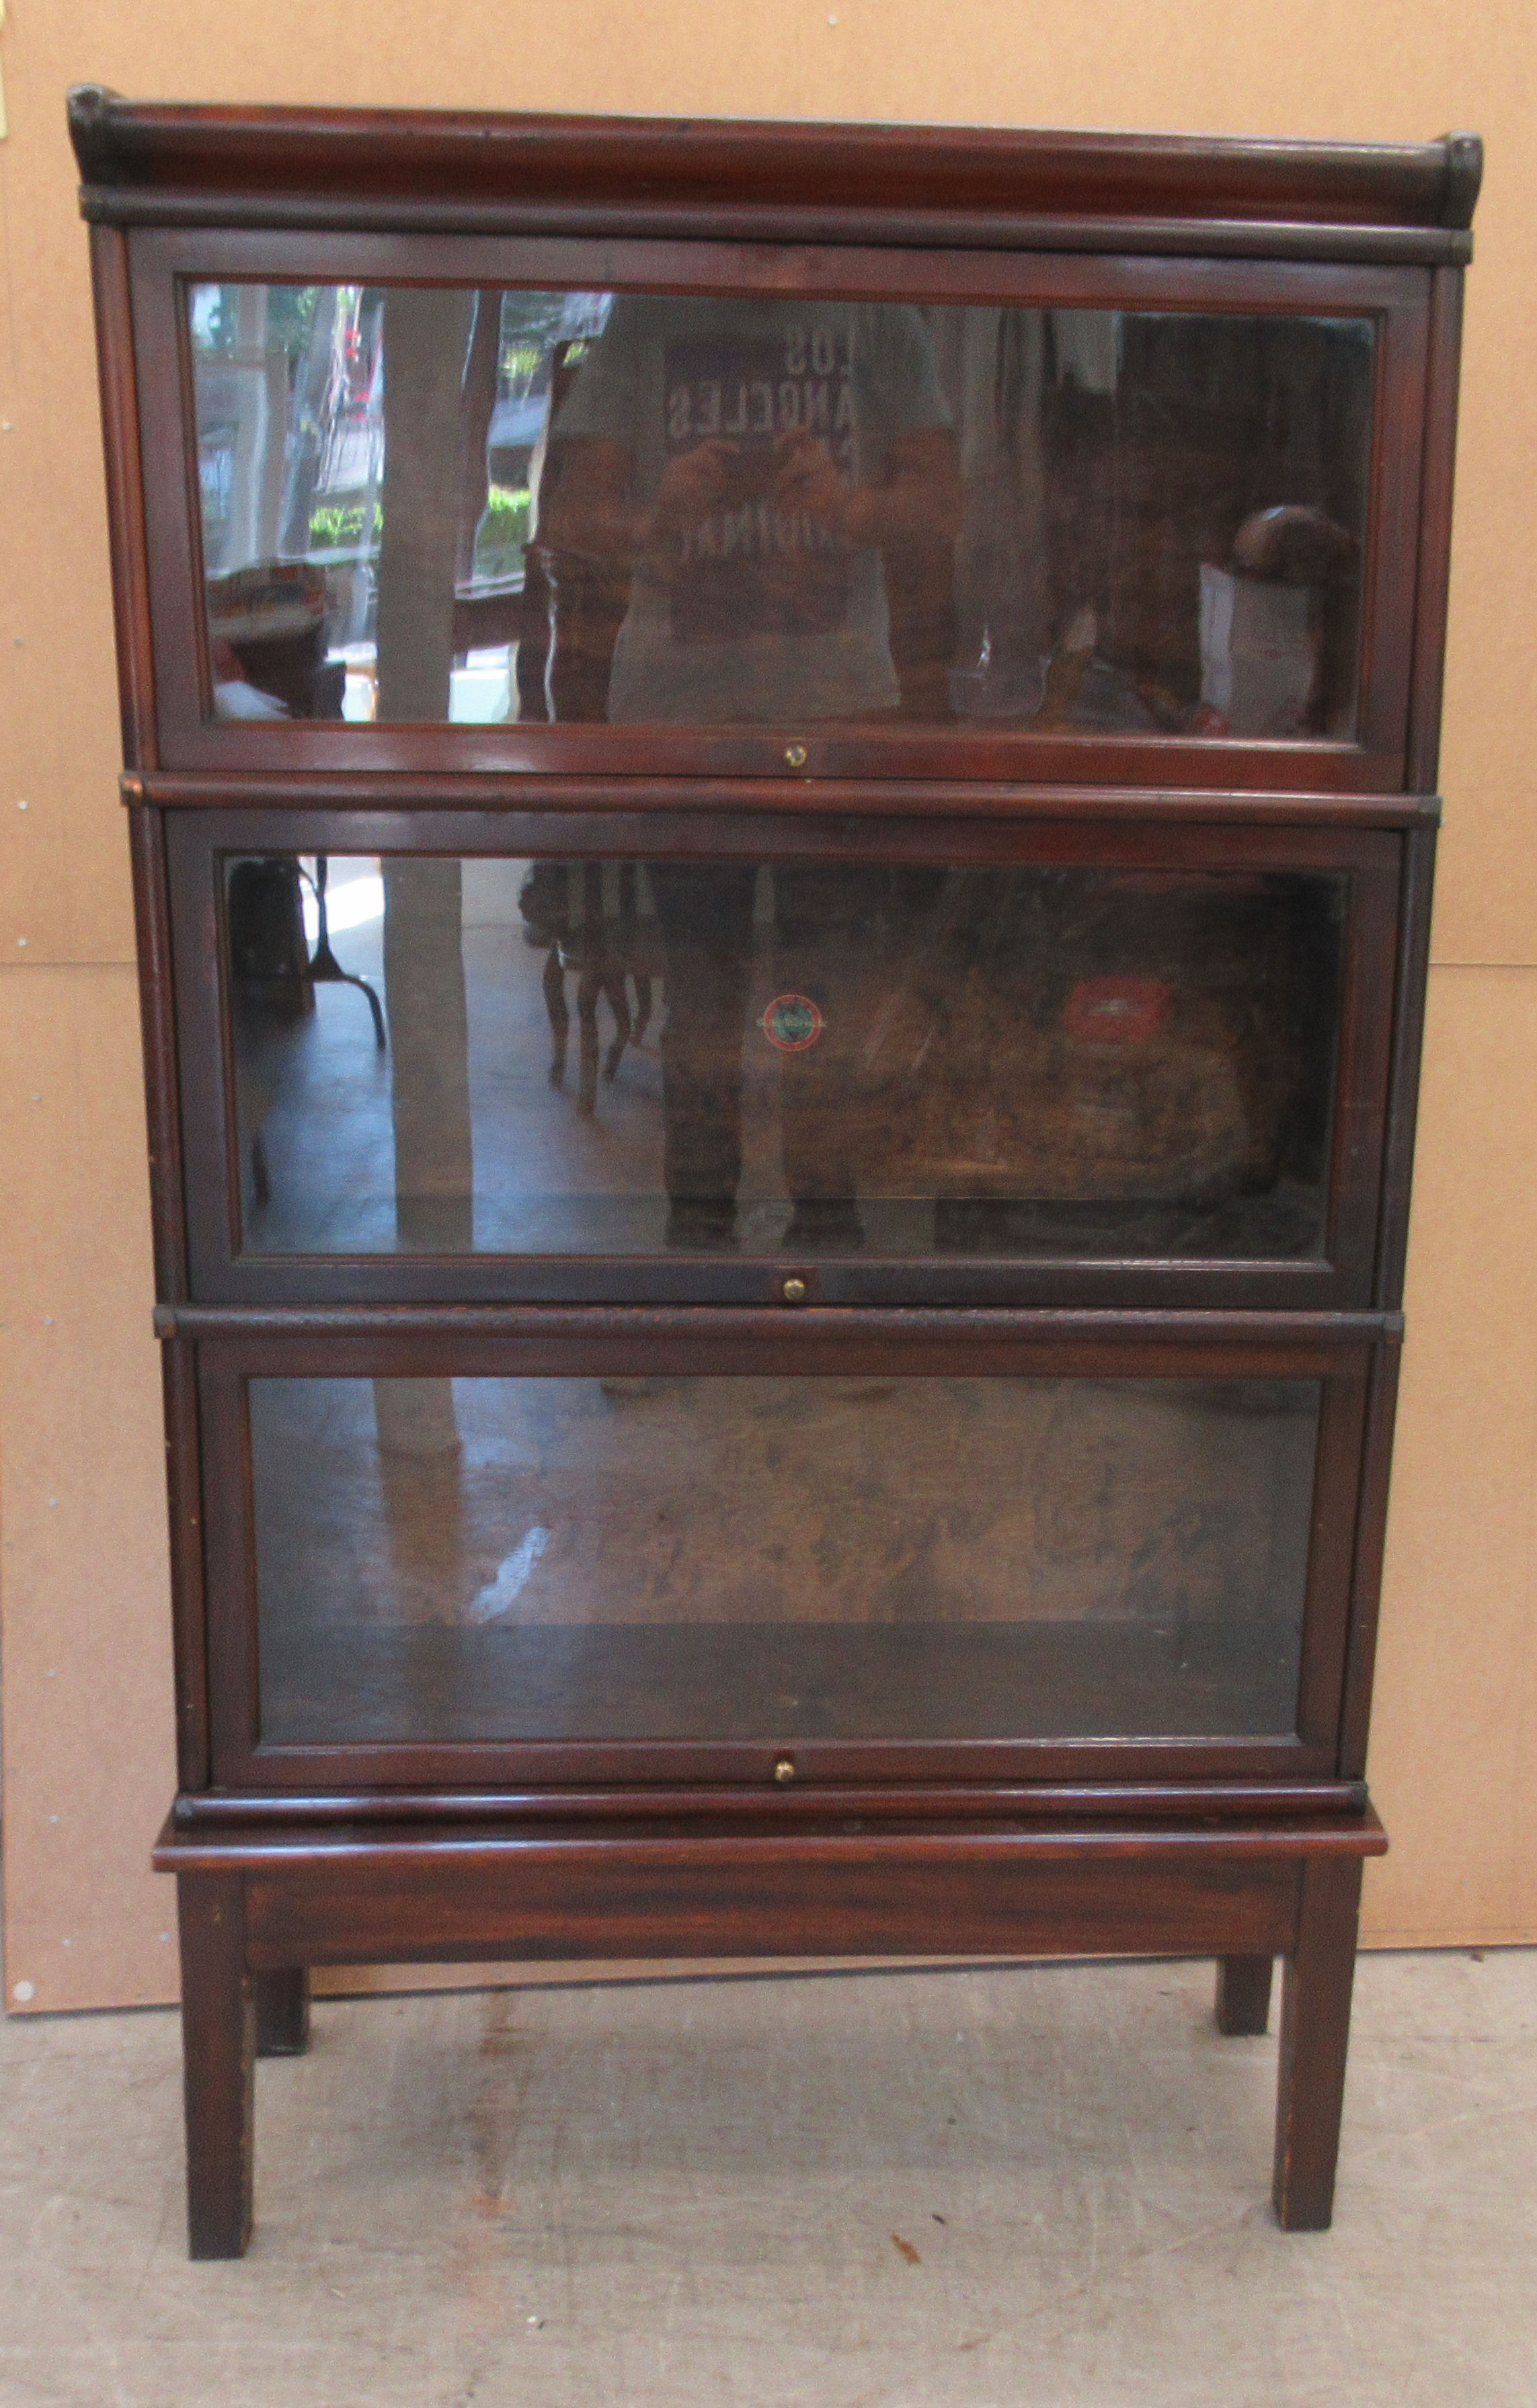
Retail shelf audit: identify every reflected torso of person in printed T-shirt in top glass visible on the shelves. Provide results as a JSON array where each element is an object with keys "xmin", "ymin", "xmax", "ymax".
[{"xmin": 540, "ymin": 294, "xmax": 961, "ymax": 725}]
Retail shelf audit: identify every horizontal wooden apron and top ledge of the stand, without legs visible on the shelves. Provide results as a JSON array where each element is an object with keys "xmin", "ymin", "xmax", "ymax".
[{"xmin": 154, "ymin": 1813, "xmax": 1385, "ymax": 1972}]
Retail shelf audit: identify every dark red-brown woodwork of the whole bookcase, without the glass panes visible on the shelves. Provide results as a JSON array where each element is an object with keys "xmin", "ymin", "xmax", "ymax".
[{"xmin": 70, "ymin": 87, "xmax": 1482, "ymax": 2256}]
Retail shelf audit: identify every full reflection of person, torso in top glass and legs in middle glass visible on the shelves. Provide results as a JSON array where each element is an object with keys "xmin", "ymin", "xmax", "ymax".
[{"xmin": 540, "ymin": 296, "xmax": 961, "ymax": 1245}]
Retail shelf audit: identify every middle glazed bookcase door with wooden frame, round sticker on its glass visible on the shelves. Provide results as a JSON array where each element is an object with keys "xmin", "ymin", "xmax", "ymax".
[{"xmin": 171, "ymin": 811, "xmax": 1405, "ymax": 1305}]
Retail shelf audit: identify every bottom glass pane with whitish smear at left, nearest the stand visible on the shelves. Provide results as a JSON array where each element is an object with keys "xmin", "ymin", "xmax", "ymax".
[{"xmin": 251, "ymin": 1377, "xmax": 1321, "ymax": 1743}]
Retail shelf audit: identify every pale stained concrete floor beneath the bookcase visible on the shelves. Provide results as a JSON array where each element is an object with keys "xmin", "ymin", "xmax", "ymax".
[{"xmin": 0, "ymin": 1953, "xmax": 1537, "ymax": 2408}]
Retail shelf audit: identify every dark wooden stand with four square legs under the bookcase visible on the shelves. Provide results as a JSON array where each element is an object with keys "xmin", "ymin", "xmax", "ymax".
[{"xmin": 154, "ymin": 1813, "xmax": 1388, "ymax": 2259}]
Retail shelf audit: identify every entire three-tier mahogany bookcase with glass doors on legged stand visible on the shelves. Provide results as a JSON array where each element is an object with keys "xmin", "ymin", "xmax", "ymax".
[{"xmin": 70, "ymin": 87, "xmax": 1482, "ymax": 2256}]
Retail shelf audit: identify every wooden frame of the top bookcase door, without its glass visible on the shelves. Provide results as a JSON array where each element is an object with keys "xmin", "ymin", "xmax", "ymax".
[{"xmin": 120, "ymin": 227, "xmax": 1431, "ymax": 795}]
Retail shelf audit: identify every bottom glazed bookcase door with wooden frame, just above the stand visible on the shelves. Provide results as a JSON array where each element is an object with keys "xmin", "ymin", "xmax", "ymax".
[{"xmin": 202, "ymin": 1310, "xmax": 1371, "ymax": 1789}]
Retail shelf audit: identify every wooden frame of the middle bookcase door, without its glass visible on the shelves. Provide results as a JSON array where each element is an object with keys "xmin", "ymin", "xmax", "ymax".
[{"xmin": 166, "ymin": 782, "xmax": 1407, "ymax": 1310}]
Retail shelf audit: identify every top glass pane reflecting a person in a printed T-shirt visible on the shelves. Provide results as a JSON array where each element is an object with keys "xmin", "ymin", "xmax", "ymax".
[{"xmin": 188, "ymin": 284, "xmax": 1376, "ymax": 737}]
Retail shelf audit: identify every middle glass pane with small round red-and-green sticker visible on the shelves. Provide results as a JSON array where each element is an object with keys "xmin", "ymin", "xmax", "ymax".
[{"xmin": 227, "ymin": 855, "xmax": 1347, "ymax": 1259}]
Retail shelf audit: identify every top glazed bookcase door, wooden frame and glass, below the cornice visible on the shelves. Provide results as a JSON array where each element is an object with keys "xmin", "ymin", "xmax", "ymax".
[{"xmin": 132, "ymin": 229, "xmax": 1431, "ymax": 792}]
